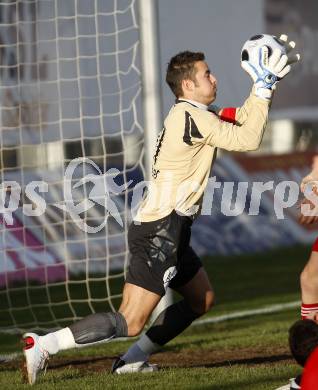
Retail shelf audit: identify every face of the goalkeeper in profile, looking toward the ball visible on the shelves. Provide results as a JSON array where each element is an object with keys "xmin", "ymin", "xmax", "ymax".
[{"xmin": 193, "ymin": 61, "xmax": 217, "ymax": 105}]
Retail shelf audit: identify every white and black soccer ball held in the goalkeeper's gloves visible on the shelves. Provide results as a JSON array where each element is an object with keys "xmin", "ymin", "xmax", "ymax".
[{"xmin": 241, "ymin": 34, "xmax": 286, "ymax": 69}]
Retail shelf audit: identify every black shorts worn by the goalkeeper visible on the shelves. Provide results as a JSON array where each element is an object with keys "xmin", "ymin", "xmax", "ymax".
[{"xmin": 126, "ymin": 211, "xmax": 202, "ymax": 296}]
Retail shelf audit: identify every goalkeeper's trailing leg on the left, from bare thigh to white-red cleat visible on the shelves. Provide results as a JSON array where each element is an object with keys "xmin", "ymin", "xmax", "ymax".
[{"xmin": 23, "ymin": 284, "xmax": 160, "ymax": 384}]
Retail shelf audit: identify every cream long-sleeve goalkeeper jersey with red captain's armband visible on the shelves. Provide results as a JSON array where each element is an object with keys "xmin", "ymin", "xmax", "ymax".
[{"xmin": 134, "ymin": 91, "xmax": 270, "ymax": 222}]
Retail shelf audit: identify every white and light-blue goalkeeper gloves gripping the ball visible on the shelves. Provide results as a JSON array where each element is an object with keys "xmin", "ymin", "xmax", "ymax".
[{"xmin": 241, "ymin": 35, "xmax": 300, "ymax": 100}]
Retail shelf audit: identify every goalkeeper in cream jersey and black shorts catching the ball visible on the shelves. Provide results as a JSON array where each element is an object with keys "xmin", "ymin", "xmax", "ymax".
[{"xmin": 23, "ymin": 36, "xmax": 299, "ymax": 384}]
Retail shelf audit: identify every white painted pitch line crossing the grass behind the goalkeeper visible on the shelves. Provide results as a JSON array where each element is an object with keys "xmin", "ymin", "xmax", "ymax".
[{"xmin": 0, "ymin": 301, "xmax": 301, "ymax": 364}]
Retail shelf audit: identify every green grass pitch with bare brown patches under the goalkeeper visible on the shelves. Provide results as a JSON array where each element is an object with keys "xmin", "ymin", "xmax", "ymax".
[{"xmin": 0, "ymin": 247, "xmax": 310, "ymax": 390}]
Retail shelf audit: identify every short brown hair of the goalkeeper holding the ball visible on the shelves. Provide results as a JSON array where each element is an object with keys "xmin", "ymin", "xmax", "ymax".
[{"xmin": 166, "ymin": 51, "xmax": 205, "ymax": 98}]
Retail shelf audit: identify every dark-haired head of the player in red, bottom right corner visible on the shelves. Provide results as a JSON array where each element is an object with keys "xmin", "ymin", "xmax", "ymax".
[{"xmin": 289, "ymin": 320, "xmax": 318, "ymax": 367}]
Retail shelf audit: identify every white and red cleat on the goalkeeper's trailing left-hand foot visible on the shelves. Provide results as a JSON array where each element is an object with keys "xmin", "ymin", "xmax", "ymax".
[{"xmin": 23, "ymin": 333, "xmax": 49, "ymax": 385}]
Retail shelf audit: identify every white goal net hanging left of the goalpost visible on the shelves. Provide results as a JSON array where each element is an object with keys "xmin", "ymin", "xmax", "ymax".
[{"xmin": 0, "ymin": 0, "xmax": 145, "ymax": 332}]
